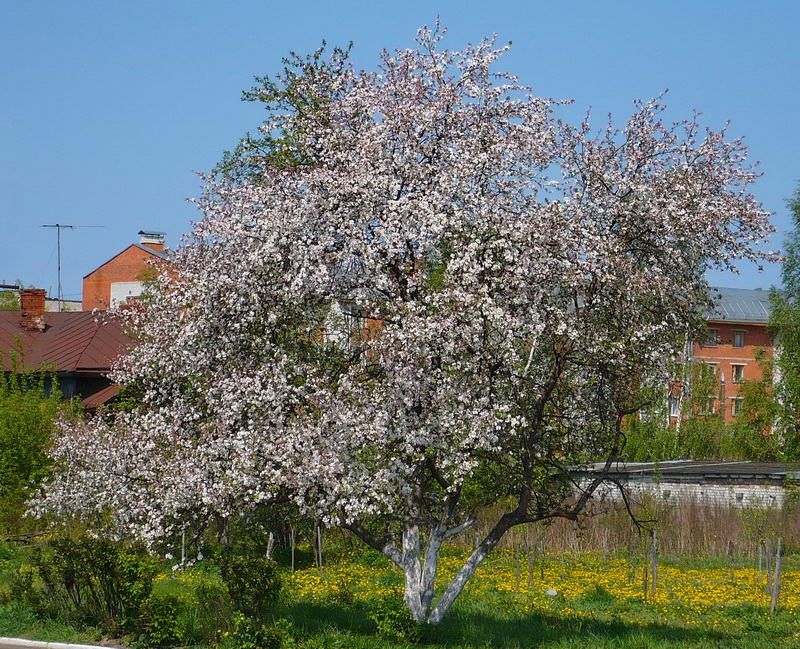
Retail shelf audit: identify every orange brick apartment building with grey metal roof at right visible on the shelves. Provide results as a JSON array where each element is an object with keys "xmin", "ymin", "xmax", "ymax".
[{"xmin": 669, "ymin": 287, "xmax": 774, "ymax": 424}]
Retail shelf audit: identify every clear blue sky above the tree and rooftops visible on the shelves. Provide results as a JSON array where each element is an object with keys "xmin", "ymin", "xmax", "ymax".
[{"xmin": 0, "ymin": 0, "xmax": 800, "ymax": 299}]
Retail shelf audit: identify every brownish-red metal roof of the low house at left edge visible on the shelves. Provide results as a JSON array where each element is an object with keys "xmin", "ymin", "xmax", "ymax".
[{"xmin": 0, "ymin": 311, "xmax": 131, "ymax": 373}]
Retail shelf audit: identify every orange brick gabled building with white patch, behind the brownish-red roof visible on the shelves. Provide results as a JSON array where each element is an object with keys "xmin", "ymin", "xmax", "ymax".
[{"xmin": 83, "ymin": 230, "xmax": 167, "ymax": 311}]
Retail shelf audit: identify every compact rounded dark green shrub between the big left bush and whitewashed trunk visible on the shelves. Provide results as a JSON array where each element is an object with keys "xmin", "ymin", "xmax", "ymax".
[{"xmin": 220, "ymin": 555, "xmax": 281, "ymax": 619}]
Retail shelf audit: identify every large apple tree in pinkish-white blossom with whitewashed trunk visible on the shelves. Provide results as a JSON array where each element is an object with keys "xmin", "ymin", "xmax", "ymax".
[{"xmin": 36, "ymin": 29, "xmax": 771, "ymax": 624}]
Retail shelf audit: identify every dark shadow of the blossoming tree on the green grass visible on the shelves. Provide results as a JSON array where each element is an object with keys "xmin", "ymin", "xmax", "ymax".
[{"xmin": 281, "ymin": 602, "xmax": 737, "ymax": 649}]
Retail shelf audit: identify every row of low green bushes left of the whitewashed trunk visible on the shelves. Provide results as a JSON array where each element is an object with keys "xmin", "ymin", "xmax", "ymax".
[{"xmin": 0, "ymin": 534, "xmax": 420, "ymax": 649}]
